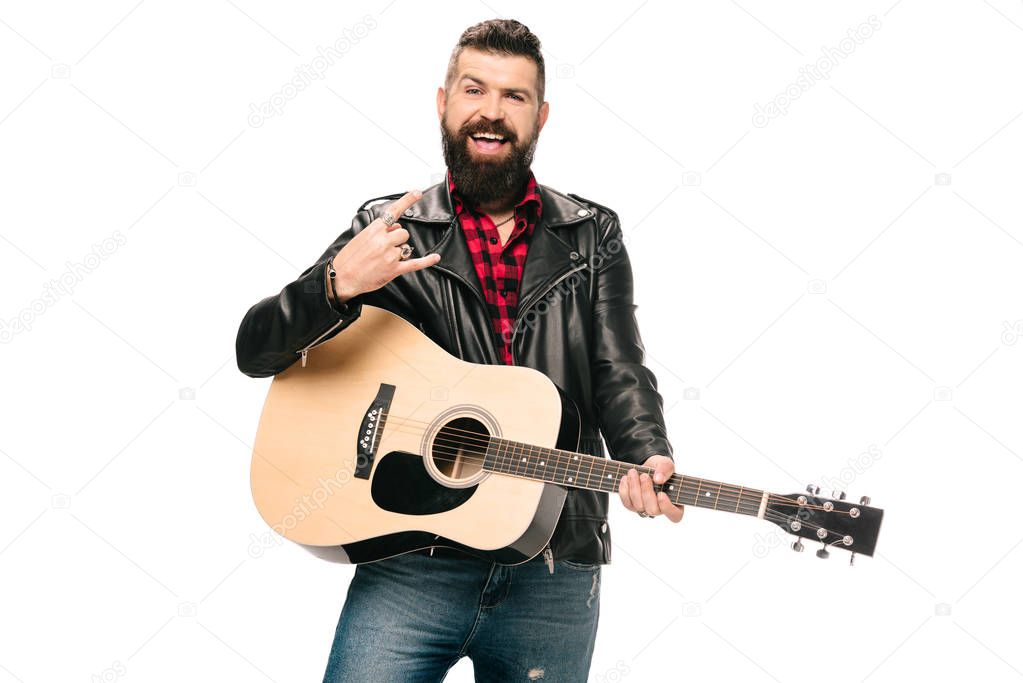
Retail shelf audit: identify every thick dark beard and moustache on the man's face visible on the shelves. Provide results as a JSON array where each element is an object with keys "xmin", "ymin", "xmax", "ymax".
[{"xmin": 441, "ymin": 116, "xmax": 539, "ymax": 208}]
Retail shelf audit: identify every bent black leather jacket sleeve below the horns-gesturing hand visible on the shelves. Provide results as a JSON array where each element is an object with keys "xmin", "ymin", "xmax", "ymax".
[{"xmin": 234, "ymin": 210, "xmax": 411, "ymax": 377}]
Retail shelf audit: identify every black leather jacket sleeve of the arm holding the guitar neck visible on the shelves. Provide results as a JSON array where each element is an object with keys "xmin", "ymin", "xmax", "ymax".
[{"xmin": 591, "ymin": 215, "xmax": 674, "ymax": 465}]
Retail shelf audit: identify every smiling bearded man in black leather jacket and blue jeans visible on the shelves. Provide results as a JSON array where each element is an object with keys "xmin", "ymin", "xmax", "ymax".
[{"xmin": 237, "ymin": 19, "xmax": 682, "ymax": 682}]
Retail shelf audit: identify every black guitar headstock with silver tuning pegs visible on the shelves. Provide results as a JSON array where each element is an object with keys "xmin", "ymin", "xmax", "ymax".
[{"xmin": 764, "ymin": 485, "xmax": 884, "ymax": 564}]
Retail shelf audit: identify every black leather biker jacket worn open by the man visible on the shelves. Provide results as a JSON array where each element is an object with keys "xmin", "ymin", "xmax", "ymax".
[{"xmin": 236, "ymin": 182, "xmax": 672, "ymax": 564}]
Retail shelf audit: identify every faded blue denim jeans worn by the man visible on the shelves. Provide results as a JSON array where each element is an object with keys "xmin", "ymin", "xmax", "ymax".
[{"xmin": 323, "ymin": 551, "xmax": 601, "ymax": 683}]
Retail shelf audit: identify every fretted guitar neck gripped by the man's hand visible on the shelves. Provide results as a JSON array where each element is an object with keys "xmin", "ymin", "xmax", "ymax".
[{"xmin": 483, "ymin": 437, "xmax": 767, "ymax": 517}]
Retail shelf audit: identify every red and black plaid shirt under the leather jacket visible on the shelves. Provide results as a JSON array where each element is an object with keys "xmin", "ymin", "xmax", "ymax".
[{"xmin": 448, "ymin": 171, "xmax": 543, "ymax": 365}]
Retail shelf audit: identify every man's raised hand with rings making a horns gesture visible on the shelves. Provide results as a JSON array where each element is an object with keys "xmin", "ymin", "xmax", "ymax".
[{"xmin": 333, "ymin": 190, "xmax": 441, "ymax": 304}]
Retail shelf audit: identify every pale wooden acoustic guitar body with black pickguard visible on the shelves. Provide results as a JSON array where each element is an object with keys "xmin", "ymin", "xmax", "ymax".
[{"xmin": 251, "ymin": 306, "xmax": 579, "ymax": 564}]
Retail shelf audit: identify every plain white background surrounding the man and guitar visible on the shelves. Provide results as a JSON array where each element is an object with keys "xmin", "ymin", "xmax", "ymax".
[{"xmin": 0, "ymin": 0, "xmax": 1023, "ymax": 683}]
